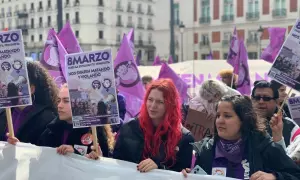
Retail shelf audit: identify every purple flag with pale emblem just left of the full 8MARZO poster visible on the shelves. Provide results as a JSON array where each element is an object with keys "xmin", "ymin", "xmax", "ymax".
[{"xmin": 41, "ymin": 29, "xmax": 67, "ymax": 86}]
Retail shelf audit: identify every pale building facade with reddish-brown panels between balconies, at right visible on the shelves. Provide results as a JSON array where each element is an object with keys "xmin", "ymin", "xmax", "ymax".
[{"xmin": 155, "ymin": 0, "xmax": 300, "ymax": 61}]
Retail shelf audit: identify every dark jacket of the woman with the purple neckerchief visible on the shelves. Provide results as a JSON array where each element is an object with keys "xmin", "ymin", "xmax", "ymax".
[{"xmin": 194, "ymin": 132, "xmax": 300, "ymax": 180}]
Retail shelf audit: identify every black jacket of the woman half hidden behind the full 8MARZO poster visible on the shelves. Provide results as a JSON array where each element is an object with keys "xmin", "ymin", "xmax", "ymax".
[{"xmin": 38, "ymin": 118, "xmax": 109, "ymax": 157}]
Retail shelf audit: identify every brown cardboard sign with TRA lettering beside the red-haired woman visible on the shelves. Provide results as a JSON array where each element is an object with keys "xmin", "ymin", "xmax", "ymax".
[{"xmin": 185, "ymin": 109, "xmax": 215, "ymax": 142}]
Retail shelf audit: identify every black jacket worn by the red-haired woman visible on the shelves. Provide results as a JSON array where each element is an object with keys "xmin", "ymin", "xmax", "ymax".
[{"xmin": 113, "ymin": 119, "xmax": 194, "ymax": 172}]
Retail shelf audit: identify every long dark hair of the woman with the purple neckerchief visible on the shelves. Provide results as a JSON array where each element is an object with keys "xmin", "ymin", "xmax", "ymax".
[{"xmin": 214, "ymin": 95, "xmax": 266, "ymax": 138}]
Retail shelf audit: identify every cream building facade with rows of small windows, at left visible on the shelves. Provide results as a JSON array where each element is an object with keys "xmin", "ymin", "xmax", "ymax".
[{"xmin": 0, "ymin": 0, "xmax": 155, "ymax": 64}]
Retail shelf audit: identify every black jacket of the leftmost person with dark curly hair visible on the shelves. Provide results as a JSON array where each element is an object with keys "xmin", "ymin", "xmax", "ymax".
[{"xmin": 0, "ymin": 104, "xmax": 55, "ymax": 145}]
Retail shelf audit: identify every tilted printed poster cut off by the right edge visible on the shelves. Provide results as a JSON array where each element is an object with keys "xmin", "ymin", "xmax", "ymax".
[{"xmin": 268, "ymin": 19, "xmax": 300, "ymax": 91}]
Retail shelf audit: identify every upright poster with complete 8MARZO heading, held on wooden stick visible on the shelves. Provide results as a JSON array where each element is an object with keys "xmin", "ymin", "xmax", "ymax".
[{"xmin": 66, "ymin": 49, "xmax": 120, "ymax": 128}]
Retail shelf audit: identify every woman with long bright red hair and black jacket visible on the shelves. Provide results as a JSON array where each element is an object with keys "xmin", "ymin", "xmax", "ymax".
[{"xmin": 113, "ymin": 79, "xmax": 194, "ymax": 172}]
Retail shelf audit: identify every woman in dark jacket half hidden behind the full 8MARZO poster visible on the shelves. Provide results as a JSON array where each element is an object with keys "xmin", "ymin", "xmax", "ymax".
[{"xmin": 39, "ymin": 84, "xmax": 114, "ymax": 159}]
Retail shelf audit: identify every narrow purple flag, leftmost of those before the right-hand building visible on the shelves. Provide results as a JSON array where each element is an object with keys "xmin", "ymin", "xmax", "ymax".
[{"xmin": 227, "ymin": 27, "xmax": 239, "ymax": 74}]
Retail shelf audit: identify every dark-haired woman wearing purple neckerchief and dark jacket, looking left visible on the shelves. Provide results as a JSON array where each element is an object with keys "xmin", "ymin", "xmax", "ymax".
[{"xmin": 182, "ymin": 95, "xmax": 300, "ymax": 180}]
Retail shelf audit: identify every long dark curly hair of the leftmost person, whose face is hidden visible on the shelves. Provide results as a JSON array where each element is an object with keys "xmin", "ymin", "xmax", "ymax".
[{"xmin": 27, "ymin": 61, "xmax": 58, "ymax": 111}]
